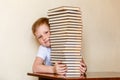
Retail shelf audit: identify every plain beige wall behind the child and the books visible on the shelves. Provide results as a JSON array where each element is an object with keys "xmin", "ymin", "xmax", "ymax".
[{"xmin": 0, "ymin": 0, "xmax": 120, "ymax": 80}]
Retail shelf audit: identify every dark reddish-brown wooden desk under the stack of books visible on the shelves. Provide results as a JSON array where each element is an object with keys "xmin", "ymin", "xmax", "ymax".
[{"xmin": 27, "ymin": 72, "xmax": 120, "ymax": 80}]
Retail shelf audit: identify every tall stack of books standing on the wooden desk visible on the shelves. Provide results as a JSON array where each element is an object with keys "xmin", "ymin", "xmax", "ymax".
[{"xmin": 48, "ymin": 6, "xmax": 82, "ymax": 77}]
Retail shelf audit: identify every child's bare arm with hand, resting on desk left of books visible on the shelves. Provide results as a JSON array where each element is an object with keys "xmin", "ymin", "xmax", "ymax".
[{"xmin": 33, "ymin": 57, "xmax": 67, "ymax": 74}]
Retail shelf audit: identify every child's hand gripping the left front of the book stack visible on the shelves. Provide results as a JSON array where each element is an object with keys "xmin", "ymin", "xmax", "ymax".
[{"xmin": 54, "ymin": 61, "xmax": 67, "ymax": 75}]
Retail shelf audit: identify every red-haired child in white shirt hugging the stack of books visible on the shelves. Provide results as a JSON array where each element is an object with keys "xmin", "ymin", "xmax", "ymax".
[{"xmin": 32, "ymin": 17, "xmax": 87, "ymax": 75}]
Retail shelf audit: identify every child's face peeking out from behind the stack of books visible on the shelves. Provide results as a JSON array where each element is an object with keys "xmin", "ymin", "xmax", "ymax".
[{"xmin": 35, "ymin": 24, "xmax": 50, "ymax": 47}]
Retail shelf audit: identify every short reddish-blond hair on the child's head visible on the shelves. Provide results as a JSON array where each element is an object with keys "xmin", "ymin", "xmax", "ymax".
[{"xmin": 32, "ymin": 17, "xmax": 50, "ymax": 35}]
